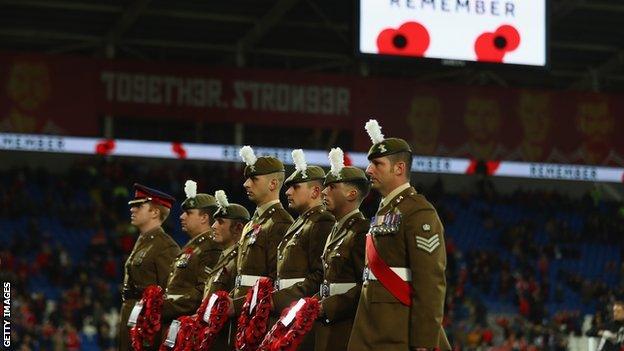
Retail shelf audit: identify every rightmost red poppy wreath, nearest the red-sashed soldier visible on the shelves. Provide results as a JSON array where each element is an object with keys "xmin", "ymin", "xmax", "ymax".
[{"xmin": 258, "ymin": 297, "xmax": 320, "ymax": 351}]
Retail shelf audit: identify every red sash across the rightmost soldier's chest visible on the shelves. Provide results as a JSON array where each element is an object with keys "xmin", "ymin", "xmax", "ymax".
[{"xmin": 366, "ymin": 233, "xmax": 412, "ymax": 306}]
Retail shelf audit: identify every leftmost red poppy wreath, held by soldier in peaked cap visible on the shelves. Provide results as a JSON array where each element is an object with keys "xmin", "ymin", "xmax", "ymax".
[{"xmin": 130, "ymin": 285, "xmax": 164, "ymax": 351}]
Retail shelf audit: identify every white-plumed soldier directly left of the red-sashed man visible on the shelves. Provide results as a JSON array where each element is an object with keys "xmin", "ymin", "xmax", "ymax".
[{"xmin": 314, "ymin": 148, "xmax": 370, "ymax": 351}]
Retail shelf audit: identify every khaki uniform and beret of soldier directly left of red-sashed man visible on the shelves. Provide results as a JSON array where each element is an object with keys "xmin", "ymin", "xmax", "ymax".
[{"xmin": 314, "ymin": 162, "xmax": 369, "ymax": 351}]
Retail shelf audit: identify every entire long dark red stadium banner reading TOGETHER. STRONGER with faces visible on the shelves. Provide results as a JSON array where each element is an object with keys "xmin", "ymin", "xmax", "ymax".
[{"xmin": 0, "ymin": 53, "xmax": 624, "ymax": 165}]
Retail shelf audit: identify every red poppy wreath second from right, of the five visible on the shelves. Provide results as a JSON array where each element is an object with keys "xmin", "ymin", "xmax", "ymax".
[{"xmin": 235, "ymin": 277, "xmax": 273, "ymax": 350}]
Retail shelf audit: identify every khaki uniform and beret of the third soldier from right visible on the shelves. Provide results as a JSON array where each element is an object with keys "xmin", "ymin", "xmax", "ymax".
[{"xmin": 273, "ymin": 166, "xmax": 336, "ymax": 350}]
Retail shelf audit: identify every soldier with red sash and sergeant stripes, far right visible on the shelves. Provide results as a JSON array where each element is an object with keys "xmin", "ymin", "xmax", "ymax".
[{"xmin": 348, "ymin": 120, "xmax": 451, "ymax": 351}]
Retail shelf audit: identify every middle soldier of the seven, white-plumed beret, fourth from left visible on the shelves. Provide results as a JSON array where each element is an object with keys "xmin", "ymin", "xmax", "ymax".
[{"xmin": 231, "ymin": 146, "xmax": 293, "ymax": 316}]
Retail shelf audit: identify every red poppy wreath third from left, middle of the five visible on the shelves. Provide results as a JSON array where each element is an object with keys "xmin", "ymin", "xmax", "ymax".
[{"xmin": 197, "ymin": 290, "xmax": 230, "ymax": 351}]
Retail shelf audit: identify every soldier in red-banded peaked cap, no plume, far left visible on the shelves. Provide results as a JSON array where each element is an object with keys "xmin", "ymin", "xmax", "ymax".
[{"xmin": 119, "ymin": 184, "xmax": 180, "ymax": 350}]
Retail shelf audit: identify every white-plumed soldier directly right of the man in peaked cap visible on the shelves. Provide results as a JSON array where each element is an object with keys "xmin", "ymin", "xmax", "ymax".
[{"xmin": 162, "ymin": 180, "xmax": 221, "ymax": 329}]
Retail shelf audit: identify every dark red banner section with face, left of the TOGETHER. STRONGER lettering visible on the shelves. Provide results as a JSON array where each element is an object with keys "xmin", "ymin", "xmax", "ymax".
[{"xmin": 0, "ymin": 54, "xmax": 98, "ymax": 135}]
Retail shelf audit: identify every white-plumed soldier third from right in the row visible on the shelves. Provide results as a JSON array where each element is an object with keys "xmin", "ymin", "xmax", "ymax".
[{"xmin": 272, "ymin": 149, "xmax": 336, "ymax": 350}]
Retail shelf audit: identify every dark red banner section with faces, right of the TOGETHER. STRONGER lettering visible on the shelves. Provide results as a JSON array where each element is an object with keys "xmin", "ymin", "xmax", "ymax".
[{"xmin": 354, "ymin": 80, "xmax": 624, "ymax": 165}]
